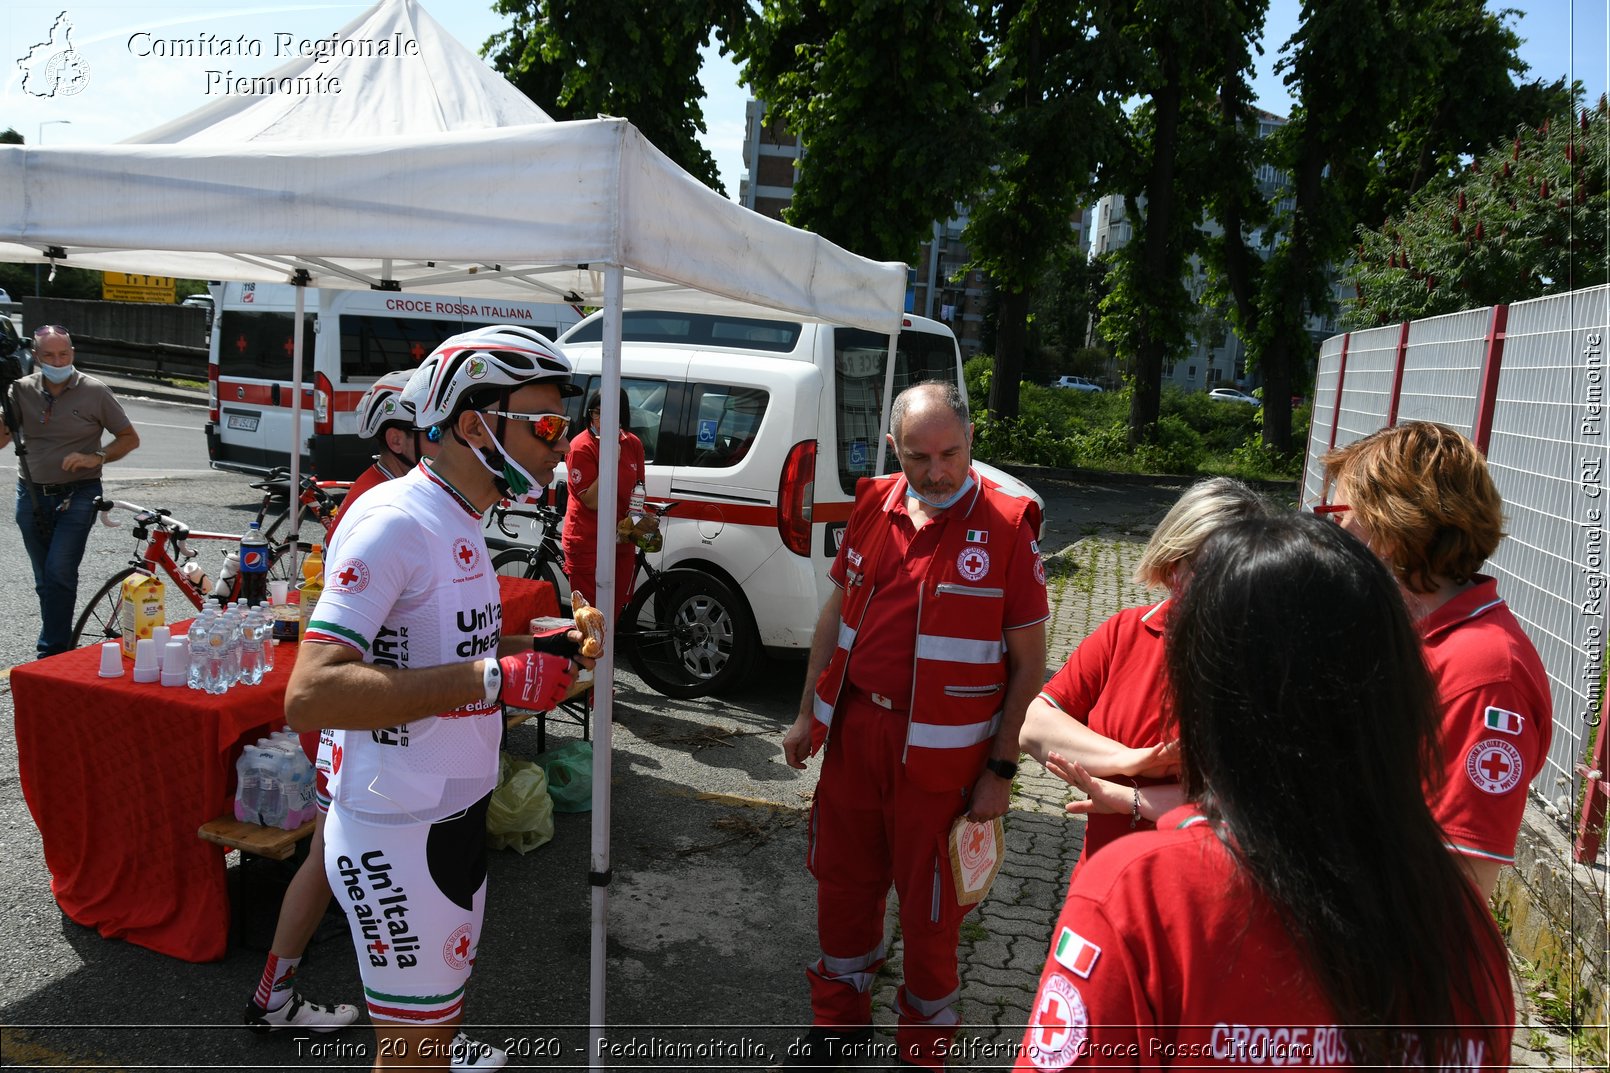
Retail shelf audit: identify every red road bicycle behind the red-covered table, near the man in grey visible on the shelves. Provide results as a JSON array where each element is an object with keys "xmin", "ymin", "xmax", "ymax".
[{"xmin": 72, "ymin": 498, "xmax": 308, "ymax": 648}]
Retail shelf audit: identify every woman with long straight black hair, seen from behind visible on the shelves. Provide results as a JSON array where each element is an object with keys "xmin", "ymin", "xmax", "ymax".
[{"xmin": 1018, "ymin": 516, "xmax": 1515, "ymax": 1070}]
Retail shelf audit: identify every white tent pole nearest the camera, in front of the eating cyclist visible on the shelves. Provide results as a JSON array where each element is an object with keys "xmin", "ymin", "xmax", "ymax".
[{"xmin": 588, "ymin": 264, "xmax": 631, "ymax": 1070}]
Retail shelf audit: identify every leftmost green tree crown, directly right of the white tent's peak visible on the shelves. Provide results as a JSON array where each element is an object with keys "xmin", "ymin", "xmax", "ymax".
[{"xmin": 483, "ymin": 0, "xmax": 749, "ymax": 193}]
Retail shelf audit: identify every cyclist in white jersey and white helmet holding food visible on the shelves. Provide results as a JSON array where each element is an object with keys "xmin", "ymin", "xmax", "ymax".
[{"xmin": 285, "ymin": 325, "xmax": 591, "ymax": 1070}]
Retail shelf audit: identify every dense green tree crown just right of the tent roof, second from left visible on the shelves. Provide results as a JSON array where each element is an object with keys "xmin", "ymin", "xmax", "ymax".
[{"xmin": 737, "ymin": 0, "xmax": 985, "ymax": 263}]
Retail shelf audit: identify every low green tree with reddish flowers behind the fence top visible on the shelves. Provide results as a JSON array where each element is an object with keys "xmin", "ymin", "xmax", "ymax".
[{"xmin": 1348, "ymin": 97, "xmax": 1610, "ymax": 327}]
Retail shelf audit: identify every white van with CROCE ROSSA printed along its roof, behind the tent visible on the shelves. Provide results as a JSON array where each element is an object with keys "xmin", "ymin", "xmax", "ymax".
[{"xmin": 206, "ymin": 284, "xmax": 580, "ymax": 480}]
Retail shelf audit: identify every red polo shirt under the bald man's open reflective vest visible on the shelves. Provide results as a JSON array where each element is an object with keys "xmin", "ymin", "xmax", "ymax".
[{"xmin": 828, "ymin": 480, "xmax": 1050, "ymax": 709}]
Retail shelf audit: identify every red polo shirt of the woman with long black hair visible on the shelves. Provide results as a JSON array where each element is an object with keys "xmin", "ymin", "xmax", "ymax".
[{"xmin": 1016, "ymin": 807, "xmax": 1515, "ymax": 1073}]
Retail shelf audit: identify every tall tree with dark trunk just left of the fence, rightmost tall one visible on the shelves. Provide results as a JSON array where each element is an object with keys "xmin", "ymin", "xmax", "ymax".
[{"xmin": 1209, "ymin": 0, "xmax": 1563, "ymax": 451}]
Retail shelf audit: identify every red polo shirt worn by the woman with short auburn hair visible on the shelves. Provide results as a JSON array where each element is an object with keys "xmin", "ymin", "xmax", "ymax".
[{"xmin": 1418, "ymin": 575, "xmax": 1554, "ymax": 864}]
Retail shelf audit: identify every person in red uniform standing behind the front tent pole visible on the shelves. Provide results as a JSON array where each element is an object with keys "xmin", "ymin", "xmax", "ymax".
[{"xmin": 562, "ymin": 392, "xmax": 644, "ymax": 615}]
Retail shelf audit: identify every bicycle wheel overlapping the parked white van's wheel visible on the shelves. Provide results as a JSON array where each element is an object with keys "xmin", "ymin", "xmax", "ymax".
[{"xmin": 615, "ymin": 569, "xmax": 757, "ymax": 699}]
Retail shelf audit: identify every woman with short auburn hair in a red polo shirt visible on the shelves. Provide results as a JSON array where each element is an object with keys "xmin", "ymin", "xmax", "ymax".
[{"xmin": 1314, "ymin": 421, "xmax": 1554, "ymax": 896}]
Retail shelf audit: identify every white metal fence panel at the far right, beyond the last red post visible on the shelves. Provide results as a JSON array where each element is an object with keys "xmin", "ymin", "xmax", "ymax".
[{"xmin": 1488, "ymin": 287, "xmax": 1610, "ymax": 802}]
